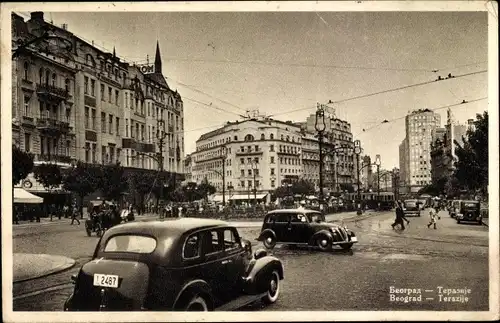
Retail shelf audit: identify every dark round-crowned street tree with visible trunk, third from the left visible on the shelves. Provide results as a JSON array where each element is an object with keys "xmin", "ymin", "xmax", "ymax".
[{"xmin": 62, "ymin": 162, "xmax": 99, "ymax": 218}]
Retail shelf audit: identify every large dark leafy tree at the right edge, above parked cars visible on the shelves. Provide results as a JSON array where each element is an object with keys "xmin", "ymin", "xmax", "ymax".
[{"xmin": 454, "ymin": 111, "xmax": 488, "ymax": 194}]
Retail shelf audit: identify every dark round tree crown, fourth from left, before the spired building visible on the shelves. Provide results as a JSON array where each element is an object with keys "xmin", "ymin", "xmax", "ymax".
[{"xmin": 97, "ymin": 163, "xmax": 128, "ymax": 201}]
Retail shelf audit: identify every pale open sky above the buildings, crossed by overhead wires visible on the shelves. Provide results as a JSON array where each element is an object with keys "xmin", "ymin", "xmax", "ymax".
[{"xmin": 16, "ymin": 8, "xmax": 488, "ymax": 169}]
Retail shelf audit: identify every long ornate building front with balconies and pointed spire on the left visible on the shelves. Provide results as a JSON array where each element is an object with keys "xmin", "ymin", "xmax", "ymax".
[{"xmin": 12, "ymin": 12, "xmax": 184, "ymax": 194}]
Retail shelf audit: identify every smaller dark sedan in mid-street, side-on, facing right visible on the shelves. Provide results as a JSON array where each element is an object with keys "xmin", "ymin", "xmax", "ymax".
[{"xmin": 257, "ymin": 208, "xmax": 358, "ymax": 251}]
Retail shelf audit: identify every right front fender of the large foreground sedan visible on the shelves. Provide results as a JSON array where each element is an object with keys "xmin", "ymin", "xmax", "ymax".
[{"xmin": 244, "ymin": 256, "xmax": 285, "ymax": 294}]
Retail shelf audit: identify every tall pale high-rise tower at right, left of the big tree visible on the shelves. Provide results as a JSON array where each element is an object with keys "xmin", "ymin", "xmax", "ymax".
[{"xmin": 400, "ymin": 109, "xmax": 441, "ymax": 192}]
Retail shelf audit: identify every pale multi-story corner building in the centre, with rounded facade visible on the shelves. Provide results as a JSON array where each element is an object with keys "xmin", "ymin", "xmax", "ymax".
[{"xmin": 191, "ymin": 118, "xmax": 302, "ymax": 200}]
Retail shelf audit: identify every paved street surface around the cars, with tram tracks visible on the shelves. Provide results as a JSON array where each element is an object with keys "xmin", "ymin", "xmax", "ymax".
[{"xmin": 13, "ymin": 212, "xmax": 488, "ymax": 311}]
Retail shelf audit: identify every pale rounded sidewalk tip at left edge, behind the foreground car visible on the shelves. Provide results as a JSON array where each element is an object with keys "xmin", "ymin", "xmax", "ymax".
[{"xmin": 12, "ymin": 253, "xmax": 75, "ymax": 283}]
